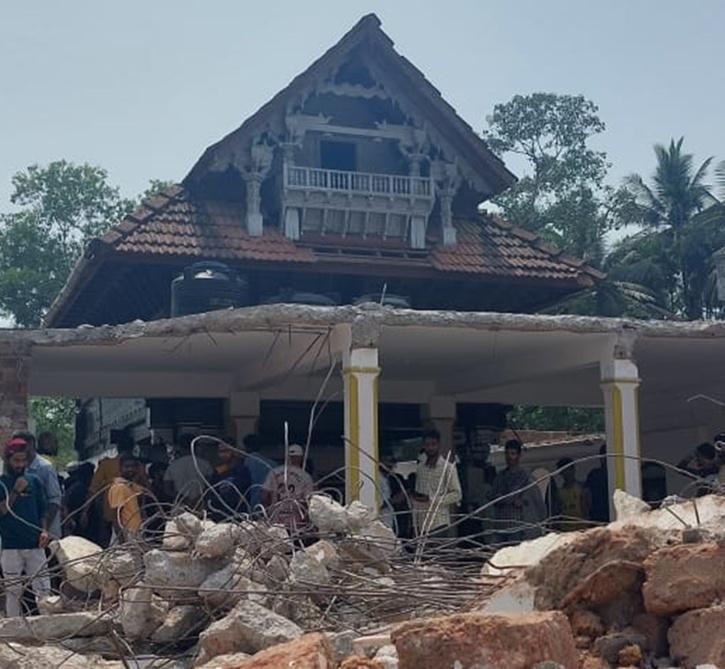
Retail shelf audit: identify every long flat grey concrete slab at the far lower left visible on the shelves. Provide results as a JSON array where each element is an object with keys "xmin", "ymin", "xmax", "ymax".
[{"xmin": 0, "ymin": 611, "xmax": 111, "ymax": 642}]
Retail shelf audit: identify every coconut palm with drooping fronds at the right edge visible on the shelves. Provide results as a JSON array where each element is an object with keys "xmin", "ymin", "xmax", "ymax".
[{"xmin": 616, "ymin": 137, "xmax": 719, "ymax": 319}]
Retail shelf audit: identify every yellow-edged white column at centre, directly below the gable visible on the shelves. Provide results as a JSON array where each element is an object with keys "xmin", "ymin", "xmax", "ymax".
[{"xmin": 343, "ymin": 348, "xmax": 380, "ymax": 510}]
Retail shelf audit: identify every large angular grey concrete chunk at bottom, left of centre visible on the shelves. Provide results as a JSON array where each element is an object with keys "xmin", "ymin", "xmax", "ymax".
[{"xmin": 199, "ymin": 600, "xmax": 302, "ymax": 659}]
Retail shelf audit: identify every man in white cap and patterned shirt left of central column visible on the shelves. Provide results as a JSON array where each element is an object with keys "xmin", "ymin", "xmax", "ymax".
[{"xmin": 262, "ymin": 444, "xmax": 314, "ymax": 536}]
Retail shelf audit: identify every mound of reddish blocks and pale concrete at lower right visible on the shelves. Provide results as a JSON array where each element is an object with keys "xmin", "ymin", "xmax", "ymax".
[{"xmin": 476, "ymin": 492, "xmax": 725, "ymax": 669}]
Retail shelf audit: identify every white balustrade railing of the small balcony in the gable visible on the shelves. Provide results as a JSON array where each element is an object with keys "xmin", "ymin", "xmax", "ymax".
[{"xmin": 285, "ymin": 165, "xmax": 433, "ymax": 198}]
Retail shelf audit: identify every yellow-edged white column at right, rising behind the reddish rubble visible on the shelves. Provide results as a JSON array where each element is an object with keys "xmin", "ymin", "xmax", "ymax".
[{"xmin": 600, "ymin": 357, "xmax": 642, "ymax": 504}]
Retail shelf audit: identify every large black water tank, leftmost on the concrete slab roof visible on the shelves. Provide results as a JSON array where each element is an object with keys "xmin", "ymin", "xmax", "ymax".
[{"xmin": 171, "ymin": 261, "xmax": 249, "ymax": 316}]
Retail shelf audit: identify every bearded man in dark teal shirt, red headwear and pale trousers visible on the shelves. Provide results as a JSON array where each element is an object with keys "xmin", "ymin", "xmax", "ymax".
[{"xmin": 0, "ymin": 437, "xmax": 50, "ymax": 617}]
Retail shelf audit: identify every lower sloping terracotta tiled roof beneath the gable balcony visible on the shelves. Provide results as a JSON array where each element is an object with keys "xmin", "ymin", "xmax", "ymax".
[{"xmin": 100, "ymin": 187, "xmax": 601, "ymax": 285}]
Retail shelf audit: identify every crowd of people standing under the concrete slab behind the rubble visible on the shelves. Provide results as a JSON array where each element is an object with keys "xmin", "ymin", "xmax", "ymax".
[{"xmin": 0, "ymin": 430, "xmax": 725, "ymax": 616}]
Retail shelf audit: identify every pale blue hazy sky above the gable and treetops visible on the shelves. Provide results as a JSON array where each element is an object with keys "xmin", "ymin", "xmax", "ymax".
[{"xmin": 0, "ymin": 0, "xmax": 725, "ymax": 206}]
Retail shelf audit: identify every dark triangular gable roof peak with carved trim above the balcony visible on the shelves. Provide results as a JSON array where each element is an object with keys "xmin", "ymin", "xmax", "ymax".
[{"xmin": 184, "ymin": 14, "xmax": 516, "ymax": 199}]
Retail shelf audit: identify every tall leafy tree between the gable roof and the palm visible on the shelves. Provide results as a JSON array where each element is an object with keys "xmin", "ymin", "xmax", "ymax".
[{"xmin": 484, "ymin": 93, "xmax": 631, "ymax": 265}]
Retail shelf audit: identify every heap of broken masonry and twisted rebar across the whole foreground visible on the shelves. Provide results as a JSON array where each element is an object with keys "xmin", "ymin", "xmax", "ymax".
[{"xmin": 0, "ymin": 493, "xmax": 725, "ymax": 669}]
